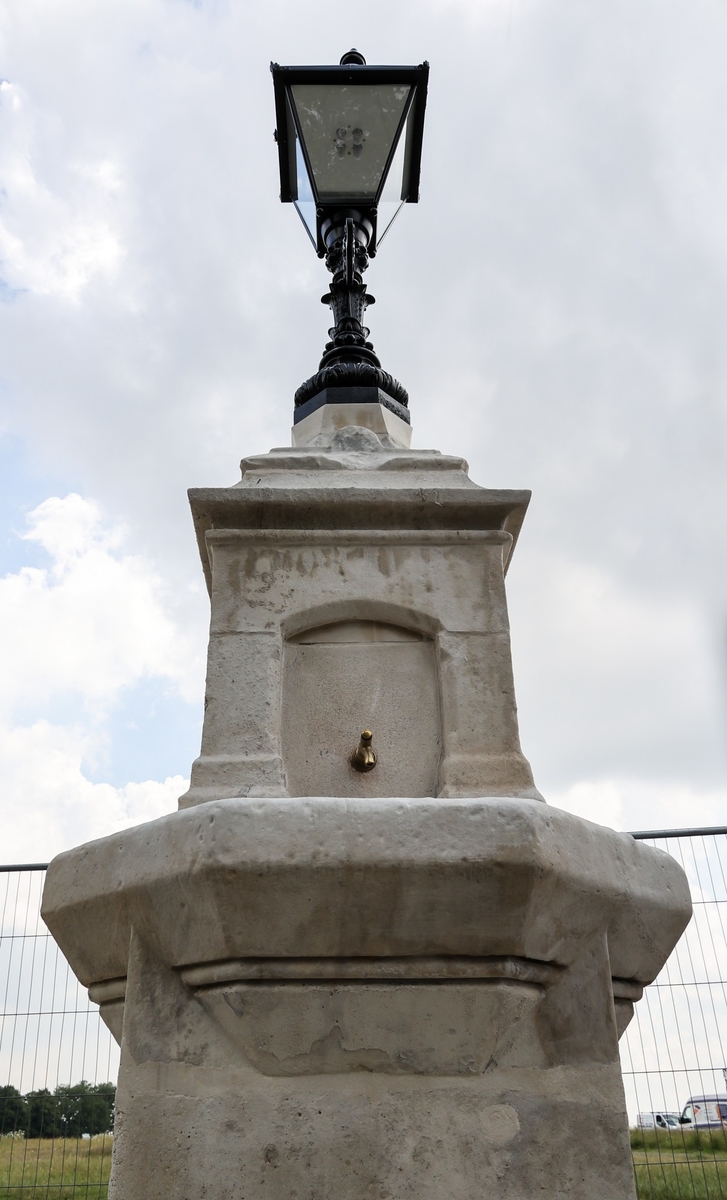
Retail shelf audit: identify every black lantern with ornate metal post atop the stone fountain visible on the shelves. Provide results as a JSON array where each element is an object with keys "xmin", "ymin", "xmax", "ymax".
[{"xmin": 270, "ymin": 50, "xmax": 429, "ymax": 421}]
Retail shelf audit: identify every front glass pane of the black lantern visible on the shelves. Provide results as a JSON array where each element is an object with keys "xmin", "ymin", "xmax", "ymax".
[{"xmin": 290, "ymin": 83, "xmax": 411, "ymax": 204}]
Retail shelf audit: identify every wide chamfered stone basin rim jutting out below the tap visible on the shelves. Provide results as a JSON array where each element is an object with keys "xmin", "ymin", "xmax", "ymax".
[{"xmin": 42, "ymin": 797, "xmax": 691, "ymax": 985}]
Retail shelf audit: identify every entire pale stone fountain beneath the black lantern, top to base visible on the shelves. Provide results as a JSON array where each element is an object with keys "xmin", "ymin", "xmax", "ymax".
[{"xmin": 43, "ymin": 406, "xmax": 691, "ymax": 1200}]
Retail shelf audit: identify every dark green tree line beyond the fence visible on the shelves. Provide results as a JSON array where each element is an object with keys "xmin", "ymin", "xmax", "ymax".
[{"xmin": 0, "ymin": 1079, "xmax": 116, "ymax": 1138}]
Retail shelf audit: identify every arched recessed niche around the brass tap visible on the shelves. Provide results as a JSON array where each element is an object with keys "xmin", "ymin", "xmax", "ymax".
[{"xmin": 281, "ymin": 620, "xmax": 441, "ymax": 796}]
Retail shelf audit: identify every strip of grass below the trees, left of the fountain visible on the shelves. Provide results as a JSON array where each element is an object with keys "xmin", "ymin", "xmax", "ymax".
[{"xmin": 0, "ymin": 1134, "xmax": 113, "ymax": 1200}]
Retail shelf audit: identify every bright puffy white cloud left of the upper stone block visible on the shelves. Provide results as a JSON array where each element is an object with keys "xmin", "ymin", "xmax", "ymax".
[{"xmin": 0, "ymin": 494, "xmax": 200, "ymax": 716}]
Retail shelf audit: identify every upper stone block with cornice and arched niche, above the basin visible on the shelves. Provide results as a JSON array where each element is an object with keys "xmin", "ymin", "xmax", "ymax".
[{"xmin": 181, "ymin": 424, "xmax": 539, "ymax": 806}]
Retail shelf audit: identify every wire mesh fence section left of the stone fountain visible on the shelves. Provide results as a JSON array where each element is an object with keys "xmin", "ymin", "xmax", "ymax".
[{"xmin": 0, "ymin": 864, "xmax": 119, "ymax": 1200}]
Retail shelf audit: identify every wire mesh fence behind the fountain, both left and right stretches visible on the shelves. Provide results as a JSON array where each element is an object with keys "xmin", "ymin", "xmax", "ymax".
[{"xmin": 0, "ymin": 828, "xmax": 727, "ymax": 1200}]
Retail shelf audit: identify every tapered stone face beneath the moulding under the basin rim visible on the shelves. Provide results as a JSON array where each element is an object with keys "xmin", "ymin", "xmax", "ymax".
[{"xmin": 197, "ymin": 979, "xmax": 547, "ymax": 1076}]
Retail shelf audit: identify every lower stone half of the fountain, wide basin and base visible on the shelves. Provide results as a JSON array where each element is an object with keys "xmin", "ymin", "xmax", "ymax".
[{"xmin": 43, "ymin": 798, "xmax": 690, "ymax": 1200}]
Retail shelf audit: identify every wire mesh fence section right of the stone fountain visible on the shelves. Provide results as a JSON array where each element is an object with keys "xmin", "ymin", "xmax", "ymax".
[{"xmin": 621, "ymin": 829, "xmax": 727, "ymax": 1200}]
